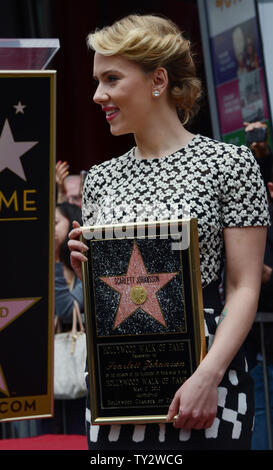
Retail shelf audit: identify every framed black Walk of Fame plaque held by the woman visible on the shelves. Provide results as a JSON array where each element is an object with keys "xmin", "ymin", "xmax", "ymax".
[{"xmin": 82, "ymin": 219, "xmax": 205, "ymax": 424}]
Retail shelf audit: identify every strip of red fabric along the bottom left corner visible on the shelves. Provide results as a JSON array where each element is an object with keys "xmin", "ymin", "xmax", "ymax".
[{"xmin": 0, "ymin": 434, "xmax": 88, "ymax": 450}]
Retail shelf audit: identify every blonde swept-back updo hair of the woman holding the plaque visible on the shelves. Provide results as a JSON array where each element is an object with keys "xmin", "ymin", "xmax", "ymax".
[{"xmin": 87, "ymin": 15, "xmax": 201, "ymax": 124}]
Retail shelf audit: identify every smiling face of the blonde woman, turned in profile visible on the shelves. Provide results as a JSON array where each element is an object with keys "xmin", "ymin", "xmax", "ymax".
[{"xmin": 93, "ymin": 52, "xmax": 153, "ymax": 135}]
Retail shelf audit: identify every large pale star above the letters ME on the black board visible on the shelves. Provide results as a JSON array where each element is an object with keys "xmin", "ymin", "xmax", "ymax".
[{"xmin": 0, "ymin": 119, "xmax": 38, "ymax": 181}]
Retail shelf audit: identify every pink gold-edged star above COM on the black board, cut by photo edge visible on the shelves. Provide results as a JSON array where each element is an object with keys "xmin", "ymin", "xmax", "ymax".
[{"xmin": 0, "ymin": 297, "xmax": 41, "ymax": 395}]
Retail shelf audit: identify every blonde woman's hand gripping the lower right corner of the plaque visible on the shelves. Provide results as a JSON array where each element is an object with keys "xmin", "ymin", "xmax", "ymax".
[{"xmin": 167, "ymin": 369, "xmax": 217, "ymax": 430}]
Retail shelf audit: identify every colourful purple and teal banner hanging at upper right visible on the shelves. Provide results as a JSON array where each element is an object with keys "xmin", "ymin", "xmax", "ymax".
[{"xmin": 206, "ymin": 0, "xmax": 270, "ymax": 145}]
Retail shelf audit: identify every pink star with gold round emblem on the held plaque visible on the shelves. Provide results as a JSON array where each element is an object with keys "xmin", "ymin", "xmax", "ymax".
[{"xmin": 100, "ymin": 242, "xmax": 178, "ymax": 328}]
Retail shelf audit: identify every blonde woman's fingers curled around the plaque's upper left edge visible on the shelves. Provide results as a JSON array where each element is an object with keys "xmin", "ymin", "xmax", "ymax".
[{"xmin": 68, "ymin": 221, "xmax": 88, "ymax": 279}]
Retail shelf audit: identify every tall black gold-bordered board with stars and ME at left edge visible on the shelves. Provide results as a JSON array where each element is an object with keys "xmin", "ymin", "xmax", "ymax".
[{"xmin": 0, "ymin": 71, "xmax": 55, "ymax": 421}]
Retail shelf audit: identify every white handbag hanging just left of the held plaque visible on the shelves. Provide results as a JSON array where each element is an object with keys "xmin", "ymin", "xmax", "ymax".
[{"xmin": 54, "ymin": 301, "xmax": 87, "ymax": 399}]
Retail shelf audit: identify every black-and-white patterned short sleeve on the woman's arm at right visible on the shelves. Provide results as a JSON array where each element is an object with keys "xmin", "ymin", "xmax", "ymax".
[{"xmin": 221, "ymin": 145, "xmax": 270, "ymax": 227}]
